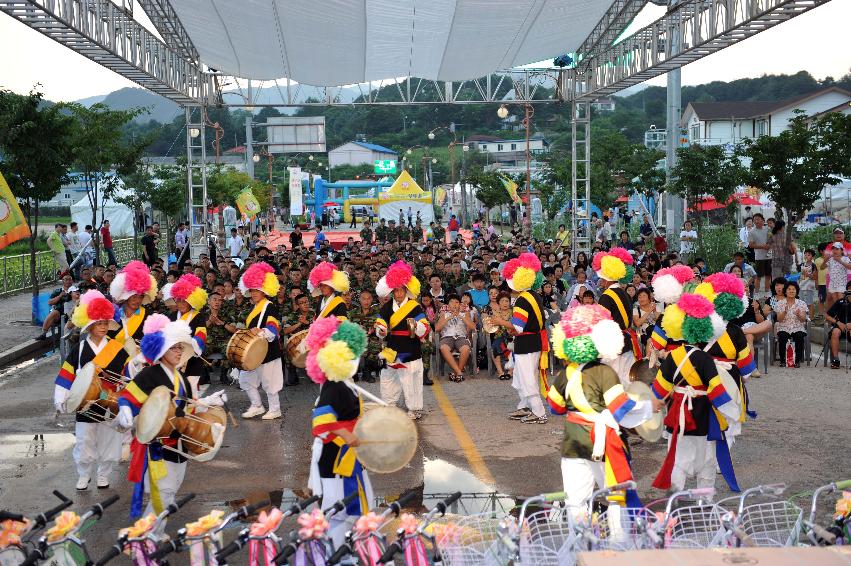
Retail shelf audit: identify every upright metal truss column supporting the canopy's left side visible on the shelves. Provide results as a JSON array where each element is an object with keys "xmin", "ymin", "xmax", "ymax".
[{"xmin": 185, "ymin": 106, "xmax": 210, "ymax": 259}]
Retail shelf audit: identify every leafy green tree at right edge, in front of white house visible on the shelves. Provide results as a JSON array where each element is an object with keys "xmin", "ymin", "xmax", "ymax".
[{"xmin": 743, "ymin": 111, "xmax": 851, "ymax": 227}]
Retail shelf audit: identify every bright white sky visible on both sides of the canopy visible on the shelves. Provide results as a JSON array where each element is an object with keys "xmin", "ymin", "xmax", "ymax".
[{"xmin": 0, "ymin": 0, "xmax": 851, "ymax": 101}]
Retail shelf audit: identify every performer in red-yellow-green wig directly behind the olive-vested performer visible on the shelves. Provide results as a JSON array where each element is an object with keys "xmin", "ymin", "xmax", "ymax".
[{"xmin": 591, "ymin": 248, "xmax": 642, "ymax": 386}]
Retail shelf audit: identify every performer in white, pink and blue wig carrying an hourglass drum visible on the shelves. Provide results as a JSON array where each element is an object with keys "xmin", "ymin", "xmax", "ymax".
[{"xmin": 118, "ymin": 314, "xmax": 227, "ymax": 518}]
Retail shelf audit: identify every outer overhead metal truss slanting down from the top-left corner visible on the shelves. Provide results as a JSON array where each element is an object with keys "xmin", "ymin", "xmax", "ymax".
[{"xmin": 0, "ymin": 0, "xmax": 212, "ymax": 105}]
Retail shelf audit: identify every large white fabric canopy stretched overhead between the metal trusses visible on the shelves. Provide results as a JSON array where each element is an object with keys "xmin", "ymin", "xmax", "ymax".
[{"xmin": 171, "ymin": 0, "xmax": 611, "ymax": 86}]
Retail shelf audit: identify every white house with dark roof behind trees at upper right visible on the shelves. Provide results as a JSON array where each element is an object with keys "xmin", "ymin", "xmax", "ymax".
[{"xmin": 680, "ymin": 87, "xmax": 851, "ymax": 145}]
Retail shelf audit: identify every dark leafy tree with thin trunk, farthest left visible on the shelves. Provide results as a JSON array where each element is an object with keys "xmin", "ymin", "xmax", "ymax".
[{"xmin": 0, "ymin": 91, "xmax": 73, "ymax": 304}]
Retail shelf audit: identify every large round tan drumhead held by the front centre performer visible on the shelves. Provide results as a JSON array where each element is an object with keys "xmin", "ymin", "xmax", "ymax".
[{"xmin": 355, "ymin": 406, "xmax": 418, "ymax": 474}]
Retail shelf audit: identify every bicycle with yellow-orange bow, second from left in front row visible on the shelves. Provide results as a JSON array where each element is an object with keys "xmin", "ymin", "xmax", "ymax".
[{"xmin": 21, "ymin": 495, "xmax": 119, "ymax": 566}]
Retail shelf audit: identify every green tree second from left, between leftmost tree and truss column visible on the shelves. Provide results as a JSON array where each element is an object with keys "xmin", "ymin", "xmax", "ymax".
[{"xmin": 64, "ymin": 103, "xmax": 152, "ymax": 258}]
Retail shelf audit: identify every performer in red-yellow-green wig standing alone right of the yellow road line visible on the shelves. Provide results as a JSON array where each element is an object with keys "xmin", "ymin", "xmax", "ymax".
[{"xmin": 502, "ymin": 253, "xmax": 550, "ymax": 424}]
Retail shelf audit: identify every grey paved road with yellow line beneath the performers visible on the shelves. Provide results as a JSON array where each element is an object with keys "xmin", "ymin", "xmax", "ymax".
[{"xmin": 0, "ymin": 356, "xmax": 851, "ymax": 564}]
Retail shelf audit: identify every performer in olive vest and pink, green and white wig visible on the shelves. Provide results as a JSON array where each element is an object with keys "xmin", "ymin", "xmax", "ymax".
[{"xmin": 547, "ymin": 305, "xmax": 663, "ymax": 510}]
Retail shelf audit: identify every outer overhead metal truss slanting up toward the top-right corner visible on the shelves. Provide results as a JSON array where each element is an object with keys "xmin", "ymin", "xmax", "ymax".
[{"xmin": 582, "ymin": 0, "xmax": 830, "ymax": 96}]
